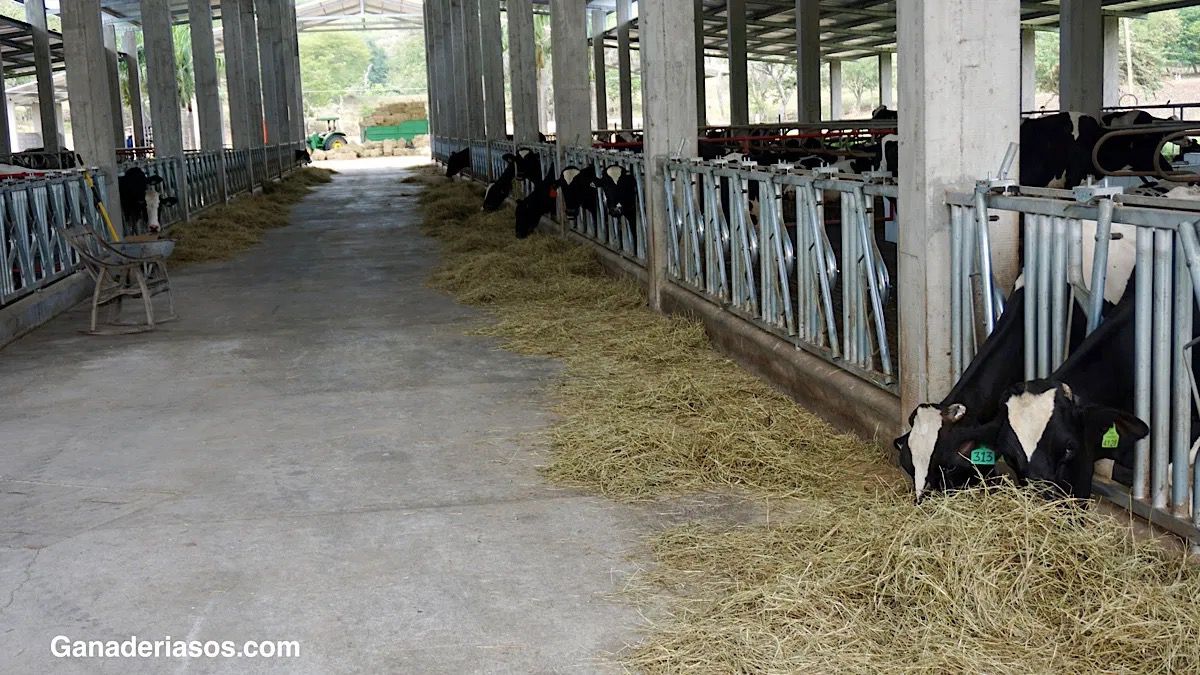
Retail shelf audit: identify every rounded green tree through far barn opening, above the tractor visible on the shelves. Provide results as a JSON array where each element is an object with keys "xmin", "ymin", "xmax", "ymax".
[{"xmin": 300, "ymin": 32, "xmax": 371, "ymax": 108}]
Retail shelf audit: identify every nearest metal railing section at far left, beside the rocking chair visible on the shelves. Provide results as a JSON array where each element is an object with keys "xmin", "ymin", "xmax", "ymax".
[{"xmin": 0, "ymin": 172, "xmax": 107, "ymax": 305}]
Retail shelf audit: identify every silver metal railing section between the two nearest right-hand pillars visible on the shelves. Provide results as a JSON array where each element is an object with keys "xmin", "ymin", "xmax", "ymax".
[{"xmin": 656, "ymin": 159, "xmax": 898, "ymax": 392}]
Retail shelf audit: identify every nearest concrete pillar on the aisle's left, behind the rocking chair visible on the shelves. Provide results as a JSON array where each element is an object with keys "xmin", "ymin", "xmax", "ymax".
[{"xmin": 62, "ymin": 0, "xmax": 121, "ymax": 228}]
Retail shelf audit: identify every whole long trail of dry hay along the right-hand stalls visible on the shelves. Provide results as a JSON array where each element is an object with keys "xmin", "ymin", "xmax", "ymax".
[{"xmin": 410, "ymin": 170, "xmax": 1200, "ymax": 673}]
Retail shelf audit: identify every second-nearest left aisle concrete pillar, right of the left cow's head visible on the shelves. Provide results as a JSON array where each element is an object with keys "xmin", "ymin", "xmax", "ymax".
[{"xmin": 141, "ymin": 0, "xmax": 187, "ymax": 198}]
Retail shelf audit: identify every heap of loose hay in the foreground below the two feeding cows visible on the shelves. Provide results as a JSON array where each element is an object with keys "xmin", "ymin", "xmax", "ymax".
[{"xmin": 629, "ymin": 488, "xmax": 1200, "ymax": 674}]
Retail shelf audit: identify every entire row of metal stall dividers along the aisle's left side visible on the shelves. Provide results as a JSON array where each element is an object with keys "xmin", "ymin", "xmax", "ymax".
[{"xmin": 0, "ymin": 143, "xmax": 305, "ymax": 306}]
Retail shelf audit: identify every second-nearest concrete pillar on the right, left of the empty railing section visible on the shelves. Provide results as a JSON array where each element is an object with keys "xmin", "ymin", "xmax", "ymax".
[{"xmin": 638, "ymin": 0, "xmax": 697, "ymax": 310}]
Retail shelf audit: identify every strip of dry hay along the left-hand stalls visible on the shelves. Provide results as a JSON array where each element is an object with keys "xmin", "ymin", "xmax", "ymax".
[{"xmin": 167, "ymin": 167, "xmax": 334, "ymax": 264}]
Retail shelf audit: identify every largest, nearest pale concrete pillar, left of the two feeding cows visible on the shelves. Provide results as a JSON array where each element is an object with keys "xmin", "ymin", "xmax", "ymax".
[{"xmin": 896, "ymin": 0, "xmax": 1020, "ymax": 410}]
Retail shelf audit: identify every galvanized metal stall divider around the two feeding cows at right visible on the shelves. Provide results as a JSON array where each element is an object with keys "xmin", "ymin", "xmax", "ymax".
[{"xmin": 947, "ymin": 184, "xmax": 1200, "ymax": 545}]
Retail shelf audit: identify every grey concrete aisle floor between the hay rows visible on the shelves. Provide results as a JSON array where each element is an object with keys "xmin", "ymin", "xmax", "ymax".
[{"xmin": 0, "ymin": 156, "xmax": 670, "ymax": 674}]
